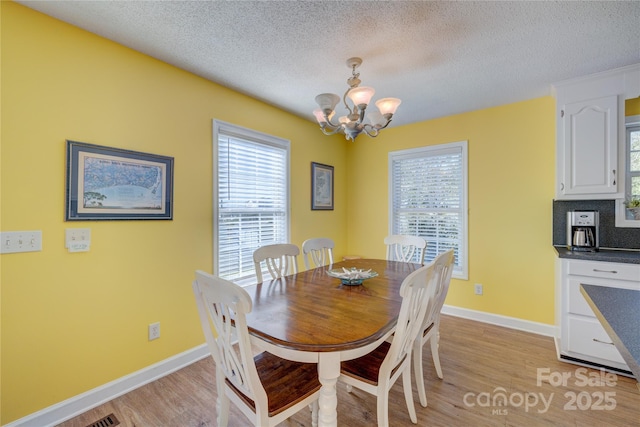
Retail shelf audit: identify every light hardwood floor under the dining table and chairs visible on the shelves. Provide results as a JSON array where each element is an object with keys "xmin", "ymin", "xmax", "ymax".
[{"xmin": 60, "ymin": 316, "xmax": 640, "ymax": 427}]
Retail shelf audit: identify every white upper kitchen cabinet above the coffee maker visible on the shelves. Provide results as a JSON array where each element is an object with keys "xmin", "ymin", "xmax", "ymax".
[{"xmin": 553, "ymin": 64, "xmax": 640, "ymax": 200}]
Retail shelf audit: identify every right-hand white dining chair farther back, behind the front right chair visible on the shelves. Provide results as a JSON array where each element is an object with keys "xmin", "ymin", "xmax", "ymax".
[{"xmin": 413, "ymin": 249, "xmax": 455, "ymax": 407}]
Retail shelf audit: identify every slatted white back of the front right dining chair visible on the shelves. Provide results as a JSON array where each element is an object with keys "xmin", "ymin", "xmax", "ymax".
[{"xmin": 380, "ymin": 263, "xmax": 436, "ymax": 371}]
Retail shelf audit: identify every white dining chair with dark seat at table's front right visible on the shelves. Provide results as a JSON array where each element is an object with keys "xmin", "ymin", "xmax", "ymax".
[{"xmin": 339, "ymin": 264, "xmax": 435, "ymax": 427}]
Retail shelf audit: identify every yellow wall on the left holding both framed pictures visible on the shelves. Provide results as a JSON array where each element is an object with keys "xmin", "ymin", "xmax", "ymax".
[{"xmin": 0, "ymin": 2, "xmax": 347, "ymax": 424}]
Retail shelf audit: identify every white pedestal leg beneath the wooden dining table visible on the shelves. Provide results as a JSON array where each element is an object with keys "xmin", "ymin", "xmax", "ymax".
[{"xmin": 318, "ymin": 353, "xmax": 340, "ymax": 427}]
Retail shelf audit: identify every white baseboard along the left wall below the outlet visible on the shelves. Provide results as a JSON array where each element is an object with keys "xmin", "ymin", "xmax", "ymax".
[{"xmin": 4, "ymin": 344, "xmax": 211, "ymax": 427}]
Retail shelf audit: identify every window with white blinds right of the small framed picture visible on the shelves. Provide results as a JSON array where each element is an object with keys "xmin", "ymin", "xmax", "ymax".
[{"xmin": 389, "ymin": 141, "xmax": 468, "ymax": 279}]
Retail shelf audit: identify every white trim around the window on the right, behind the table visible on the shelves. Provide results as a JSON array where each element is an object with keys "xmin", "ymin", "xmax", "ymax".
[{"xmin": 388, "ymin": 140, "xmax": 469, "ymax": 280}]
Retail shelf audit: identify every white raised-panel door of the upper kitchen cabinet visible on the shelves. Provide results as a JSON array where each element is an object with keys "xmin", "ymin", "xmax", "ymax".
[{"xmin": 561, "ymin": 95, "xmax": 618, "ymax": 198}]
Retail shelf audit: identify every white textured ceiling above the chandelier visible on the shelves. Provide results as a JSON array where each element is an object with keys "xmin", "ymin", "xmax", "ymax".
[{"xmin": 18, "ymin": 1, "xmax": 640, "ymax": 126}]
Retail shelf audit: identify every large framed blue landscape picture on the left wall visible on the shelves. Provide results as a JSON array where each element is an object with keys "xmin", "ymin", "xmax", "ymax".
[{"xmin": 65, "ymin": 140, "xmax": 173, "ymax": 221}]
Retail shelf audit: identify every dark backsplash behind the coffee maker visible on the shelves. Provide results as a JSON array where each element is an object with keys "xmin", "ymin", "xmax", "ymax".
[{"xmin": 553, "ymin": 200, "xmax": 640, "ymax": 249}]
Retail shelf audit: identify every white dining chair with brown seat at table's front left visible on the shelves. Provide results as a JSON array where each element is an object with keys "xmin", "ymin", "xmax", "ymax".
[{"xmin": 193, "ymin": 271, "xmax": 321, "ymax": 427}]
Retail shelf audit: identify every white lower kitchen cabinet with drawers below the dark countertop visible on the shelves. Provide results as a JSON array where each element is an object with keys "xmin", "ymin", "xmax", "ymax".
[{"xmin": 557, "ymin": 259, "xmax": 640, "ymax": 371}]
